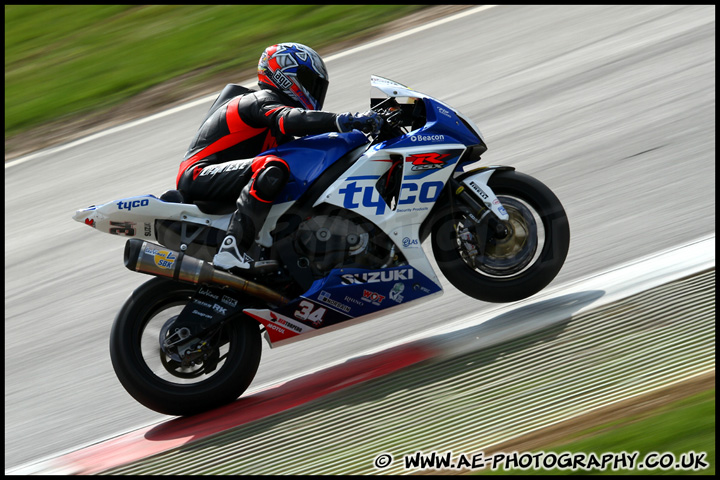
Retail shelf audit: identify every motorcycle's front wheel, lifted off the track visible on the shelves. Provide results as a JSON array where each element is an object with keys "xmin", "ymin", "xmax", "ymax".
[{"xmin": 432, "ymin": 171, "xmax": 570, "ymax": 303}]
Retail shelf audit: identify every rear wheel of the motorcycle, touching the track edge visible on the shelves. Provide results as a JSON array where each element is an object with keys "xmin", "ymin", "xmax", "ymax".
[{"xmin": 110, "ymin": 278, "xmax": 262, "ymax": 416}]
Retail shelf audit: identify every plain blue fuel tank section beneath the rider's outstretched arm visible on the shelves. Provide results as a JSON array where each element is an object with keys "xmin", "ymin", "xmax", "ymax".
[{"xmin": 263, "ymin": 131, "xmax": 368, "ymax": 203}]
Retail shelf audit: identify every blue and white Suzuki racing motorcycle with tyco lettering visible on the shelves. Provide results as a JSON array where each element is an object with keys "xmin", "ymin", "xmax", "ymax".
[{"xmin": 74, "ymin": 76, "xmax": 570, "ymax": 416}]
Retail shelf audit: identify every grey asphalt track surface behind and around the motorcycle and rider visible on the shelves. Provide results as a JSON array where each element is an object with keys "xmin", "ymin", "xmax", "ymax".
[{"xmin": 5, "ymin": 2, "xmax": 715, "ymax": 468}]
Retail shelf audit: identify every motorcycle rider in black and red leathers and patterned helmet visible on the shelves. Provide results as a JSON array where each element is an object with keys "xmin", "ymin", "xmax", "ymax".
[{"xmin": 177, "ymin": 43, "xmax": 382, "ymax": 271}]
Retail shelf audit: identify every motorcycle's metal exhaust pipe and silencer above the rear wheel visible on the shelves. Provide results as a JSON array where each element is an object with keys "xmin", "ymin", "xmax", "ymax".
[{"xmin": 124, "ymin": 238, "xmax": 290, "ymax": 305}]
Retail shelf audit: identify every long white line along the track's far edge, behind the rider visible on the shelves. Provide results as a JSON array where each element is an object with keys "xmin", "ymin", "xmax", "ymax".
[{"xmin": 5, "ymin": 5, "xmax": 497, "ymax": 168}]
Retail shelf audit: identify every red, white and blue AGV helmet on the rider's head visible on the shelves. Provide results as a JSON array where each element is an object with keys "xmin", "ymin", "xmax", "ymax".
[{"xmin": 258, "ymin": 43, "xmax": 329, "ymax": 110}]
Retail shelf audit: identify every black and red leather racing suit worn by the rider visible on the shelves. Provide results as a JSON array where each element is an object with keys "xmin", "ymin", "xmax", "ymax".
[{"xmin": 177, "ymin": 86, "xmax": 338, "ymax": 249}]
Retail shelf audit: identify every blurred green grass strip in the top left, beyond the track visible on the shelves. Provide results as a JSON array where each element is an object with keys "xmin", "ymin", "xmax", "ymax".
[{"xmin": 5, "ymin": 5, "xmax": 423, "ymax": 139}]
